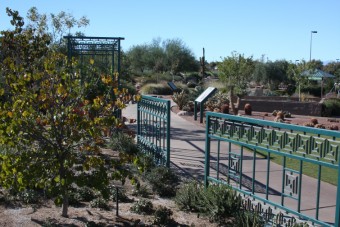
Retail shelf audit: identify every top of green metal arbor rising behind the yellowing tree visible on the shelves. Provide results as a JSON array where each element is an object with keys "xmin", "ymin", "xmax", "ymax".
[{"xmin": 64, "ymin": 36, "xmax": 124, "ymax": 86}]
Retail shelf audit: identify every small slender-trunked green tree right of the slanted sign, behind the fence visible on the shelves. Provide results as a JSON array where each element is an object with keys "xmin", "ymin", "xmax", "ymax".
[{"xmin": 218, "ymin": 52, "xmax": 254, "ymax": 113}]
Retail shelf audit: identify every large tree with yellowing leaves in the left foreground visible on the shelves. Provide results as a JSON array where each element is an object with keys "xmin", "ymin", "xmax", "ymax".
[{"xmin": 0, "ymin": 9, "xmax": 128, "ymax": 216}]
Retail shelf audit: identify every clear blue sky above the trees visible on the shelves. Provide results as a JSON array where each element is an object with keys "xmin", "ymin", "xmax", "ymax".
[{"xmin": 0, "ymin": 0, "xmax": 340, "ymax": 62}]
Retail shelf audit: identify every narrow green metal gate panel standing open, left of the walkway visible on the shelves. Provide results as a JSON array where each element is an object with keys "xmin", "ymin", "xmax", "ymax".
[{"xmin": 137, "ymin": 95, "xmax": 170, "ymax": 167}]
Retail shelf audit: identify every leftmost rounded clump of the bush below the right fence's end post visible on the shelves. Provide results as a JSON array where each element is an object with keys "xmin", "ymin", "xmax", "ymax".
[{"xmin": 175, "ymin": 181, "xmax": 204, "ymax": 212}]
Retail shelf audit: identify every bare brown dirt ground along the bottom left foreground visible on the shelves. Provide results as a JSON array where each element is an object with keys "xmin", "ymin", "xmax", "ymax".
[{"xmin": 0, "ymin": 195, "xmax": 216, "ymax": 227}]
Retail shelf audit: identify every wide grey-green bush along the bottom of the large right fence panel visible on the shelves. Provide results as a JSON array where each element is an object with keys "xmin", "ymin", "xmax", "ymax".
[{"xmin": 175, "ymin": 181, "xmax": 263, "ymax": 226}]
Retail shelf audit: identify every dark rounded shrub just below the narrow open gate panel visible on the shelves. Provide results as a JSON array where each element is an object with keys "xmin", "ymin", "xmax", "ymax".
[{"xmin": 146, "ymin": 166, "xmax": 179, "ymax": 197}]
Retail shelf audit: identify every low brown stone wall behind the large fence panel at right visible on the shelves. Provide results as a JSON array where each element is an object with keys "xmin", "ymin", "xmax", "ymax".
[{"xmin": 239, "ymin": 97, "xmax": 323, "ymax": 116}]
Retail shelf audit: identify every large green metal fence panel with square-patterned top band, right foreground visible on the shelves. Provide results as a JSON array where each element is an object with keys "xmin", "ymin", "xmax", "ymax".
[{"xmin": 205, "ymin": 112, "xmax": 340, "ymax": 226}]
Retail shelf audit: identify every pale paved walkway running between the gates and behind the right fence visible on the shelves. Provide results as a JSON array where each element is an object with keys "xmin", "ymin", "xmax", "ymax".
[{"xmin": 123, "ymin": 102, "xmax": 336, "ymax": 223}]
